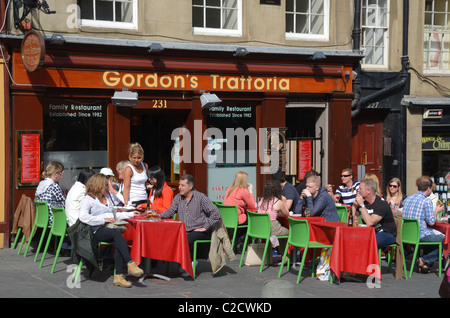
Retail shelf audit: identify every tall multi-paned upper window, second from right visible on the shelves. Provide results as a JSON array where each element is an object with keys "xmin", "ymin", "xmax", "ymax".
[{"xmin": 361, "ymin": 0, "xmax": 389, "ymax": 67}]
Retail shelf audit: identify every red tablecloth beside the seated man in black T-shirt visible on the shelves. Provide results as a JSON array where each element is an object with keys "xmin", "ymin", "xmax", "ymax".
[{"xmin": 309, "ymin": 222, "xmax": 381, "ymax": 280}]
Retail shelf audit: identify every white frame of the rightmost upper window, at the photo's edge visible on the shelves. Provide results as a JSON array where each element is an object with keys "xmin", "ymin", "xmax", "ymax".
[{"xmin": 423, "ymin": 0, "xmax": 450, "ymax": 75}]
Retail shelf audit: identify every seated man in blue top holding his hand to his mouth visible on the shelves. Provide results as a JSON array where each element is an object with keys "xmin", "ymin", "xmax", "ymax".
[{"xmin": 299, "ymin": 176, "xmax": 339, "ymax": 222}]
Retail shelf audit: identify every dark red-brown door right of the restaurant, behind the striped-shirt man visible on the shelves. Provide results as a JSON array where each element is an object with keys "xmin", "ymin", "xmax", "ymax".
[{"xmin": 352, "ymin": 120, "xmax": 383, "ymax": 187}]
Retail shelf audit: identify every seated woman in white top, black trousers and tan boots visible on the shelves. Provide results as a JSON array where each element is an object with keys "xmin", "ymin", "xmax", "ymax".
[{"xmin": 80, "ymin": 173, "xmax": 144, "ymax": 287}]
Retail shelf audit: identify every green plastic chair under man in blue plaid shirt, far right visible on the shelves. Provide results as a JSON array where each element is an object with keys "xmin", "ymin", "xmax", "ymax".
[{"xmin": 401, "ymin": 218, "xmax": 442, "ymax": 279}]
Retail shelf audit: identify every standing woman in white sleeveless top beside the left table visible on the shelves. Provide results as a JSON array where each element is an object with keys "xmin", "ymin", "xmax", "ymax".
[{"xmin": 123, "ymin": 143, "xmax": 148, "ymax": 207}]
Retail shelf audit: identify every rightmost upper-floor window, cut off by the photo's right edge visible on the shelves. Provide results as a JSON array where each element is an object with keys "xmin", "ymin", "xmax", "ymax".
[{"xmin": 423, "ymin": 0, "xmax": 450, "ymax": 72}]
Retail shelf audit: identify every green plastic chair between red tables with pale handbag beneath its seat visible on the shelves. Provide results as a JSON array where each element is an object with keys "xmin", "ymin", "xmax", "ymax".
[{"xmin": 239, "ymin": 210, "xmax": 288, "ymax": 273}]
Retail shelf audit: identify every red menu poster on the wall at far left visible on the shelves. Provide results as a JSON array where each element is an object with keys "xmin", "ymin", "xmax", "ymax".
[{"xmin": 20, "ymin": 134, "xmax": 41, "ymax": 183}]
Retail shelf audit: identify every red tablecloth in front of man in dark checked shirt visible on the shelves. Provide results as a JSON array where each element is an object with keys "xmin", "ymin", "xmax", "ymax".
[{"xmin": 123, "ymin": 217, "xmax": 194, "ymax": 277}]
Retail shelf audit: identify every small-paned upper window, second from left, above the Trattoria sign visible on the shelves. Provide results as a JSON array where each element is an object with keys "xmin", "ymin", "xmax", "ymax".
[{"xmin": 192, "ymin": 0, "xmax": 242, "ymax": 36}]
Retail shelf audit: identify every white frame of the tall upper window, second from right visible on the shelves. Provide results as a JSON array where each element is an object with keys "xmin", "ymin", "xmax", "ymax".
[{"xmin": 361, "ymin": 0, "xmax": 390, "ymax": 69}]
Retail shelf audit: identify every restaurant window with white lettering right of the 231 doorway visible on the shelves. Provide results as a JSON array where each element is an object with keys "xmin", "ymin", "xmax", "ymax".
[{"xmin": 204, "ymin": 102, "xmax": 255, "ymax": 201}]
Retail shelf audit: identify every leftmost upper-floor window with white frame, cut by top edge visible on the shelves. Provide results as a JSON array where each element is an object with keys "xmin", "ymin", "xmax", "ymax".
[{"xmin": 77, "ymin": 0, "xmax": 138, "ymax": 29}]
